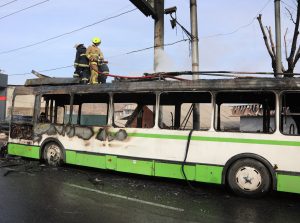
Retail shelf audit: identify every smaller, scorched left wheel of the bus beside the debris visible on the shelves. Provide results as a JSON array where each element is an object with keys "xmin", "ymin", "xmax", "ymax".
[{"xmin": 40, "ymin": 138, "xmax": 66, "ymax": 166}]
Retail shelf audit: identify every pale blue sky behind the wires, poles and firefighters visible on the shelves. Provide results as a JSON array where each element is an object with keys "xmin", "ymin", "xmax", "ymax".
[{"xmin": 0, "ymin": 0, "xmax": 300, "ymax": 84}]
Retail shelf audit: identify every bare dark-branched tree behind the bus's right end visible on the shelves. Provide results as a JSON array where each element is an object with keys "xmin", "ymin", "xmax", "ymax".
[{"xmin": 257, "ymin": 0, "xmax": 300, "ymax": 77}]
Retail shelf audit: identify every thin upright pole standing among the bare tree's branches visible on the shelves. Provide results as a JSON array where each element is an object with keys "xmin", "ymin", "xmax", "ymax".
[{"xmin": 274, "ymin": 0, "xmax": 282, "ymax": 77}]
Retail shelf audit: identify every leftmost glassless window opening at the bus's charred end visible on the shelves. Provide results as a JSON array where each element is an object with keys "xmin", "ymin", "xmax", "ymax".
[{"xmin": 12, "ymin": 95, "xmax": 35, "ymax": 122}]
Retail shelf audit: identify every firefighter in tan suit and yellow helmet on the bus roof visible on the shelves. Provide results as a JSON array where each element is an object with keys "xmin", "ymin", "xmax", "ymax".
[{"xmin": 86, "ymin": 37, "xmax": 104, "ymax": 84}]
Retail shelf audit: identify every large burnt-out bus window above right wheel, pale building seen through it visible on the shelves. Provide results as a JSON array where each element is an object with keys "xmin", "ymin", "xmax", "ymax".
[{"xmin": 215, "ymin": 92, "xmax": 276, "ymax": 133}]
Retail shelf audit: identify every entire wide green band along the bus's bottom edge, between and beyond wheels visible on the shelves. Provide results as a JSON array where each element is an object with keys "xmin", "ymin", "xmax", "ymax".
[{"xmin": 8, "ymin": 143, "xmax": 300, "ymax": 193}]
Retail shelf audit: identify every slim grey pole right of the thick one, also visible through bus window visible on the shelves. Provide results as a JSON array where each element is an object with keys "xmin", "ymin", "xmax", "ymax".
[{"xmin": 190, "ymin": 0, "xmax": 200, "ymax": 129}]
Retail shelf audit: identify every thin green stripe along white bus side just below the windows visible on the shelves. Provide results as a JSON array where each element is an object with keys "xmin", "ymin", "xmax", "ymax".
[{"xmin": 128, "ymin": 133, "xmax": 300, "ymax": 146}]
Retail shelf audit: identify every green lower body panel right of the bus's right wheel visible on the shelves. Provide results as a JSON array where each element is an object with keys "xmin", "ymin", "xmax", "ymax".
[{"xmin": 277, "ymin": 173, "xmax": 300, "ymax": 193}]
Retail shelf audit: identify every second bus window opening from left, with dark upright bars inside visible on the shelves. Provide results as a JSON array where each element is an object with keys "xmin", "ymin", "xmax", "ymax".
[{"xmin": 38, "ymin": 94, "xmax": 70, "ymax": 124}]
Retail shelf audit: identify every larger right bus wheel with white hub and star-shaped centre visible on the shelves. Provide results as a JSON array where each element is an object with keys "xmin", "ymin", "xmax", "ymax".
[{"xmin": 227, "ymin": 158, "xmax": 271, "ymax": 197}]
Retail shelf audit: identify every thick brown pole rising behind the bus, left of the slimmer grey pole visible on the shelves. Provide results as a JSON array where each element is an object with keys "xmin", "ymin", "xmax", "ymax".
[{"xmin": 154, "ymin": 0, "xmax": 165, "ymax": 72}]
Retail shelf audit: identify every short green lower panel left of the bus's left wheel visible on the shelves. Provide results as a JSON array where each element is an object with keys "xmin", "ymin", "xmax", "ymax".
[{"xmin": 8, "ymin": 143, "xmax": 40, "ymax": 159}]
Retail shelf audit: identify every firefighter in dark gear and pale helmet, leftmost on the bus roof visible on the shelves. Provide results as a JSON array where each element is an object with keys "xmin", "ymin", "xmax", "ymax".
[{"xmin": 73, "ymin": 43, "xmax": 90, "ymax": 84}]
